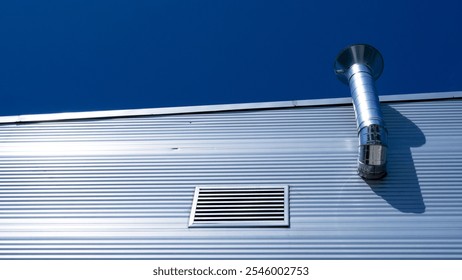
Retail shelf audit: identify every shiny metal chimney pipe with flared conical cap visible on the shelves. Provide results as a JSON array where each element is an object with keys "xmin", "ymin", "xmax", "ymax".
[{"xmin": 334, "ymin": 44, "xmax": 388, "ymax": 179}]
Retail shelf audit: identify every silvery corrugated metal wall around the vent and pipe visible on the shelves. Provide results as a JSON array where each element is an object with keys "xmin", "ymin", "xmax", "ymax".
[{"xmin": 0, "ymin": 99, "xmax": 462, "ymax": 259}]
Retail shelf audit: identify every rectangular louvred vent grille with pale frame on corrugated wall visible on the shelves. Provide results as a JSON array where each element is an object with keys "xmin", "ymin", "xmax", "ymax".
[{"xmin": 189, "ymin": 186, "xmax": 289, "ymax": 227}]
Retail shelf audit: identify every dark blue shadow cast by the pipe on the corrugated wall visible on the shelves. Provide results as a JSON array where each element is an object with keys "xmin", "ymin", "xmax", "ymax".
[{"xmin": 366, "ymin": 104, "xmax": 426, "ymax": 214}]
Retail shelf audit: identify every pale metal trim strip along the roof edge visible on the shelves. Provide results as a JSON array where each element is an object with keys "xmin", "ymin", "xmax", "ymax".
[{"xmin": 0, "ymin": 91, "xmax": 462, "ymax": 124}]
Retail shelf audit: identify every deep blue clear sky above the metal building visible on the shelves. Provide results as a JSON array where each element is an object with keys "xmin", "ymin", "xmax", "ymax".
[{"xmin": 0, "ymin": 0, "xmax": 462, "ymax": 115}]
